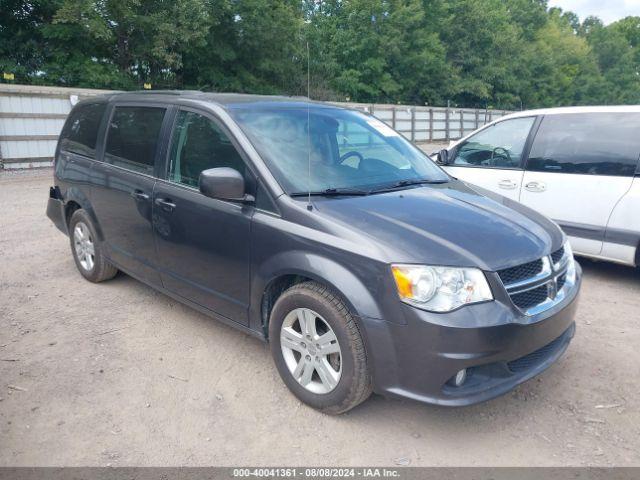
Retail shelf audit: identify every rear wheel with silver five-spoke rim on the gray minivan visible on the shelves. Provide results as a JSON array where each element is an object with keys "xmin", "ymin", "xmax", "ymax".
[{"xmin": 69, "ymin": 209, "xmax": 118, "ymax": 283}]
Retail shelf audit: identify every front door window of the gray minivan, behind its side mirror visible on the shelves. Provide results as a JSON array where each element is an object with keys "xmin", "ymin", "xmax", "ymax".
[{"xmin": 169, "ymin": 111, "xmax": 246, "ymax": 187}]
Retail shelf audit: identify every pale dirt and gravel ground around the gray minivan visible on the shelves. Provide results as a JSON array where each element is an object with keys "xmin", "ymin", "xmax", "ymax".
[{"xmin": 0, "ymin": 171, "xmax": 640, "ymax": 466}]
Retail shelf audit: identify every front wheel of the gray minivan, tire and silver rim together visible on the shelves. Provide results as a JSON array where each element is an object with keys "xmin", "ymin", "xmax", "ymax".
[{"xmin": 269, "ymin": 282, "xmax": 372, "ymax": 415}]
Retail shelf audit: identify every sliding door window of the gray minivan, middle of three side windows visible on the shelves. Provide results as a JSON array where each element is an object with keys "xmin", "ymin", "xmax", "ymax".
[{"xmin": 105, "ymin": 107, "xmax": 165, "ymax": 173}]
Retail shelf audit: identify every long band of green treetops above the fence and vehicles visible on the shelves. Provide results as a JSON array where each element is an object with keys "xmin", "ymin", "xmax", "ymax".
[{"xmin": 0, "ymin": 0, "xmax": 640, "ymax": 109}]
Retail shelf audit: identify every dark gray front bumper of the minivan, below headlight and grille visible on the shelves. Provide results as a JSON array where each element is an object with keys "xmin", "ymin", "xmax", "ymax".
[{"xmin": 361, "ymin": 262, "xmax": 582, "ymax": 406}]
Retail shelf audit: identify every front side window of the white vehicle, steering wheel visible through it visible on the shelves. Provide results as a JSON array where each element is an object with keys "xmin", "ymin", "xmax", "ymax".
[{"xmin": 453, "ymin": 117, "xmax": 535, "ymax": 168}]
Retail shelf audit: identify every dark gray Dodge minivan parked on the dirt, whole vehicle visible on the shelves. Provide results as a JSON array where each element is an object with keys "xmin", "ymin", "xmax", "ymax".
[{"xmin": 47, "ymin": 92, "xmax": 581, "ymax": 413}]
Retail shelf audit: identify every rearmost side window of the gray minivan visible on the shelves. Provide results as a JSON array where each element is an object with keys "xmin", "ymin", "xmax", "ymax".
[{"xmin": 60, "ymin": 103, "xmax": 107, "ymax": 158}]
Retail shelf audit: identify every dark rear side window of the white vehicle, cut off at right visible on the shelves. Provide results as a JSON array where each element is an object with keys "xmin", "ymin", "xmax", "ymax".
[{"xmin": 527, "ymin": 113, "xmax": 640, "ymax": 176}]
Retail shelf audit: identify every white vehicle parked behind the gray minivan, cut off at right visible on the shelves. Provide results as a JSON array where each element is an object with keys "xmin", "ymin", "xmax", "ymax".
[{"xmin": 438, "ymin": 106, "xmax": 640, "ymax": 266}]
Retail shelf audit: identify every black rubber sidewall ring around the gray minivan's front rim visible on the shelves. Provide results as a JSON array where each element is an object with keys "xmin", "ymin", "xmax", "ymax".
[{"xmin": 269, "ymin": 289, "xmax": 356, "ymax": 410}]
